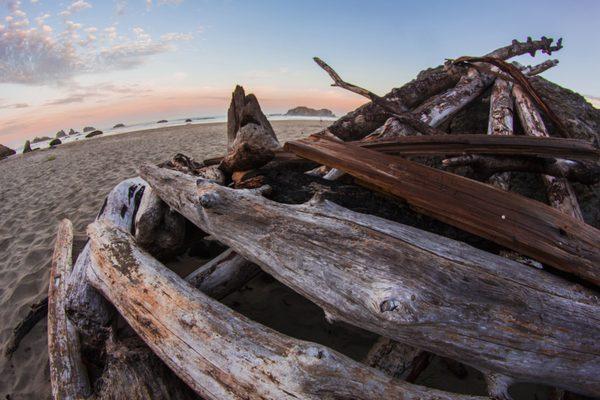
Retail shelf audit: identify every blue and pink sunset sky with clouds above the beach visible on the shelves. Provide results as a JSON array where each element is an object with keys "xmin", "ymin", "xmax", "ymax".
[{"xmin": 0, "ymin": 0, "xmax": 600, "ymax": 146}]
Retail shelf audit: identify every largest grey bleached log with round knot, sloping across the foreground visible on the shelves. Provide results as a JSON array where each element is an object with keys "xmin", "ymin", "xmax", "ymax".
[{"xmin": 140, "ymin": 166, "xmax": 600, "ymax": 395}]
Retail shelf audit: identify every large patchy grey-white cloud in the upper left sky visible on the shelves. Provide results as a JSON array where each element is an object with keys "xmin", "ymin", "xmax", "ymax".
[{"xmin": 0, "ymin": 7, "xmax": 193, "ymax": 85}]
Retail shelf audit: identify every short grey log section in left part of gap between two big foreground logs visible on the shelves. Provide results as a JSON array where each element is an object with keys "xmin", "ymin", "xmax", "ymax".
[{"xmin": 185, "ymin": 249, "xmax": 260, "ymax": 300}]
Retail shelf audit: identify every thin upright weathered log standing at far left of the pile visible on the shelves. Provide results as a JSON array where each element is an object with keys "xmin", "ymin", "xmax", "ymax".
[{"xmin": 48, "ymin": 219, "xmax": 91, "ymax": 400}]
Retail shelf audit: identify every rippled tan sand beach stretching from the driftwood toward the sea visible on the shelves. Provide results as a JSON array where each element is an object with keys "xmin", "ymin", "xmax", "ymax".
[{"xmin": 0, "ymin": 121, "xmax": 328, "ymax": 399}]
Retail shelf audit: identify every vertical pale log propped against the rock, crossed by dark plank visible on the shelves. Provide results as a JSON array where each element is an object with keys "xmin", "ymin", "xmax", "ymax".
[{"xmin": 488, "ymin": 78, "xmax": 514, "ymax": 190}]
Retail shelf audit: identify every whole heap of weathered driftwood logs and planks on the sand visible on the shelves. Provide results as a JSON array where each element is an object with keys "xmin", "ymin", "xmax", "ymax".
[{"xmin": 48, "ymin": 38, "xmax": 600, "ymax": 399}]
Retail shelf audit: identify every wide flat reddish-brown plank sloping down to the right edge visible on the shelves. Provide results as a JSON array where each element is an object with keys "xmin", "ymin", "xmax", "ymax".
[{"xmin": 282, "ymin": 136, "xmax": 600, "ymax": 285}]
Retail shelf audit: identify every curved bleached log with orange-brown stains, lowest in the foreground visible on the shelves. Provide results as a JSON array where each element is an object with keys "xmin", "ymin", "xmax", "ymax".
[{"xmin": 88, "ymin": 221, "xmax": 486, "ymax": 400}]
